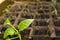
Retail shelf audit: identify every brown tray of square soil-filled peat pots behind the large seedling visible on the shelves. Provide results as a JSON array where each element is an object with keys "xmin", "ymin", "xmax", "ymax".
[{"xmin": 0, "ymin": 1, "xmax": 60, "ymax": 40}]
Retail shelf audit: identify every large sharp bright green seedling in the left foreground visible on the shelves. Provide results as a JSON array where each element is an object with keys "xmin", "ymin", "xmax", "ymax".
[{"xmin": 4, "ymin": 18, "xmax": 34, "ymax": 40}]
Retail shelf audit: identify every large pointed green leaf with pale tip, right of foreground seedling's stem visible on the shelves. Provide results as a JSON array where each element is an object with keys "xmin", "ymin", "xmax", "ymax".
[{"xmin": 18, "ymin": 19, "xmax": 34, "ymax": 31}]
